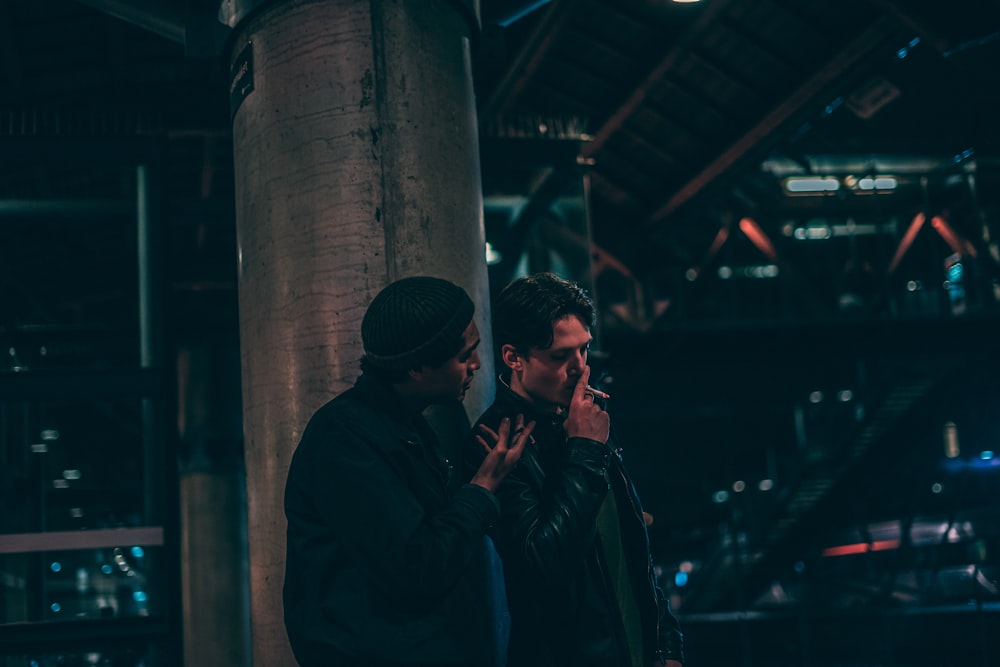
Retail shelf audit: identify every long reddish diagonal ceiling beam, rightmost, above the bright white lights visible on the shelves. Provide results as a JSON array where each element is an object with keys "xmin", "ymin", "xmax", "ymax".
[{"xmin": 643, "ymin": 19, "xmax": 892, "ymax": 228}]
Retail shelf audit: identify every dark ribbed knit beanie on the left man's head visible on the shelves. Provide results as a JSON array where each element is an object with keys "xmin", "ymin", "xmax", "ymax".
[{"xmin": 361, "ymin": 276, "xmax": 475, "ymax": 370}]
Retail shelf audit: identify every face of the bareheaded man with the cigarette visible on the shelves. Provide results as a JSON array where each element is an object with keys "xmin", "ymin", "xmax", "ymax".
[{"xmin": 502, "ymin": 315, "xmax": 593, "ymax": 409}]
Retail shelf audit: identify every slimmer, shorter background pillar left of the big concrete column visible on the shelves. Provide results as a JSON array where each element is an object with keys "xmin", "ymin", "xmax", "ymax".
[{"xmin": 177, "ymin": 343, "xmax": 250, "ymax": 667}]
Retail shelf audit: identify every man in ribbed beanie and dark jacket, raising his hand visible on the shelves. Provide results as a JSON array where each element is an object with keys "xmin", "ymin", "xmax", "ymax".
[{"xmin": 284, "ymin": 276, "xmax": 534, "ymax": 667}]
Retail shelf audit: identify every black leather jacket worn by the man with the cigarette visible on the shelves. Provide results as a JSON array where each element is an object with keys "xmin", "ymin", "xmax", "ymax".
[{"xmin": 467, "ymin": 382, "xmax": 683, "ymax": 667}]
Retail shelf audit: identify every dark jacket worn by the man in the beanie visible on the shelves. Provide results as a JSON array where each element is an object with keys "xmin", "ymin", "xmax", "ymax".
[{"xmin": 284, "ymin": 375, "xmax": 499, "ymax": 667}]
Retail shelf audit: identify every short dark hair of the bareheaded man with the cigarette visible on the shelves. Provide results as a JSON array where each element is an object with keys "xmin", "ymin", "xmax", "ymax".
[{"xmin": 493, "ymin": 273, "xmax": 597, "ymax": 352}]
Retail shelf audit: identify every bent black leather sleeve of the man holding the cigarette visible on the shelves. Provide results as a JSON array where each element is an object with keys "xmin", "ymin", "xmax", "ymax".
[{"xmin": 484, "ymin": 438, "xmax": 611, "ymax": 582}]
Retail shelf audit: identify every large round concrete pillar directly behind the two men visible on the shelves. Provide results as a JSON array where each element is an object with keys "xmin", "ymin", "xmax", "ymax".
[{"xmin": 228, "ymin": 0, "xmax": 493, "ymax": 667}]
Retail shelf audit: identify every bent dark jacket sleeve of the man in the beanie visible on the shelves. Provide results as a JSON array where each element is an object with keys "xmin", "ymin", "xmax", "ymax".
[{"xmin": 285, "ymin": 414, "xmax": 499, "ymax": 605}]
